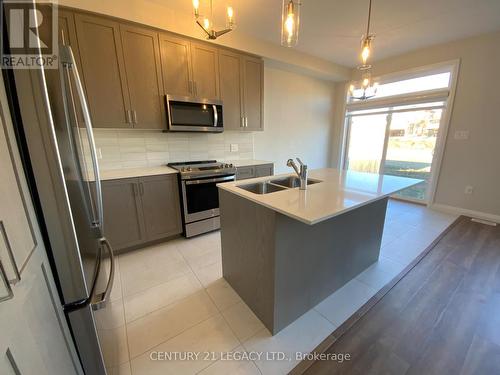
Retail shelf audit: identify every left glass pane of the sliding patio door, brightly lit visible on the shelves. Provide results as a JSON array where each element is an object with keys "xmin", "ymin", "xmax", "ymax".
[{"xmin": 347, "ymin": 115, "xmax": 387, "ymax": 173}]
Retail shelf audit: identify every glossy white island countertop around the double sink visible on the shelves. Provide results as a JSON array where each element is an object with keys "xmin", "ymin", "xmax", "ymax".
[{"xmin": 218, "ymin": 168, "xmax": 423, "ymax": 225}]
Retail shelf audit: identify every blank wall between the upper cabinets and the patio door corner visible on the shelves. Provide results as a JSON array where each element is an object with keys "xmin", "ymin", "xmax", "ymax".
[{"xmin": 254, "ymin": 66, "xmax": 334, "ymax": 173}]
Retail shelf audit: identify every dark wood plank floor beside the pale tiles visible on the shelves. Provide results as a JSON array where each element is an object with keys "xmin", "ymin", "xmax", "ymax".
[{"xmin": 303, "ymin": 217, "xmax": 500, "ymax": 375}]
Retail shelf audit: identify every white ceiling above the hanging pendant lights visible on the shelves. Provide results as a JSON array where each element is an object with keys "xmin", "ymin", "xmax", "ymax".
[{"xmin": 166, "ymin": 0, "xmax": 500, "ymax": 66}]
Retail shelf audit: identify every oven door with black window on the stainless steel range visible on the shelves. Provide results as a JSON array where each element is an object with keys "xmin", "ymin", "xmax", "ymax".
[{"xmin": 182, "ymin": 175, "xmax": 234, "ymax": 223}]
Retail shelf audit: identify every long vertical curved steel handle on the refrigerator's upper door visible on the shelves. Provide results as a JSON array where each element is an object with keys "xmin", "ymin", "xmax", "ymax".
[{"xmin": 62, "ymin": 46, "xmax": 104, "ymax": 232}]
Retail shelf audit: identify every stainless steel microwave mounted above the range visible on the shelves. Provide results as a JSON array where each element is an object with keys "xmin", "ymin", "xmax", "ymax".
[{"xmin": 166, "ymin": 95, "xmax": 224, "ymax": 133}]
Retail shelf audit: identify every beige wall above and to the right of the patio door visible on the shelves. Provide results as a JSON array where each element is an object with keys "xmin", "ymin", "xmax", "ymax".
[{"xmin": 346, "ymin": 32, "xmax": 500, "ymax": 217}]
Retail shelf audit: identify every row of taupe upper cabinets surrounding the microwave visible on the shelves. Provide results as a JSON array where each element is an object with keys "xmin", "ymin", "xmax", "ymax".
[{"xmin": 62, "ymin": 9, "xmax": 264, "ymax": 130}]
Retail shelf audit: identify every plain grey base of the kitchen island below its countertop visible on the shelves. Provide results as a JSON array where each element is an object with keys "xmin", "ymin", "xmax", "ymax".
[{"xmin": 219, "ymin": 189, "xmax": 388, "ymax": 335}]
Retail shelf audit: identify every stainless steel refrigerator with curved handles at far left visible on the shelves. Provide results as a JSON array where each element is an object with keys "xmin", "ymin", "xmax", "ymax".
[{"xmin": 9, "ymin": 39, "xmax": 115, "ymax": 375}]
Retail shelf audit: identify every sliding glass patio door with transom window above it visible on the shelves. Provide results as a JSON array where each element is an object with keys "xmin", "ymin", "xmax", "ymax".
[{"xmin": 344, "ymin": 66, "xmax": 451, "ymax": 202}]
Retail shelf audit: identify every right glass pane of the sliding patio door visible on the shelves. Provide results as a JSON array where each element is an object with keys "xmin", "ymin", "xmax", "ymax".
[{"xmin": 383, "ymin": 109, "xmax": 442, "ymax": 200}]
